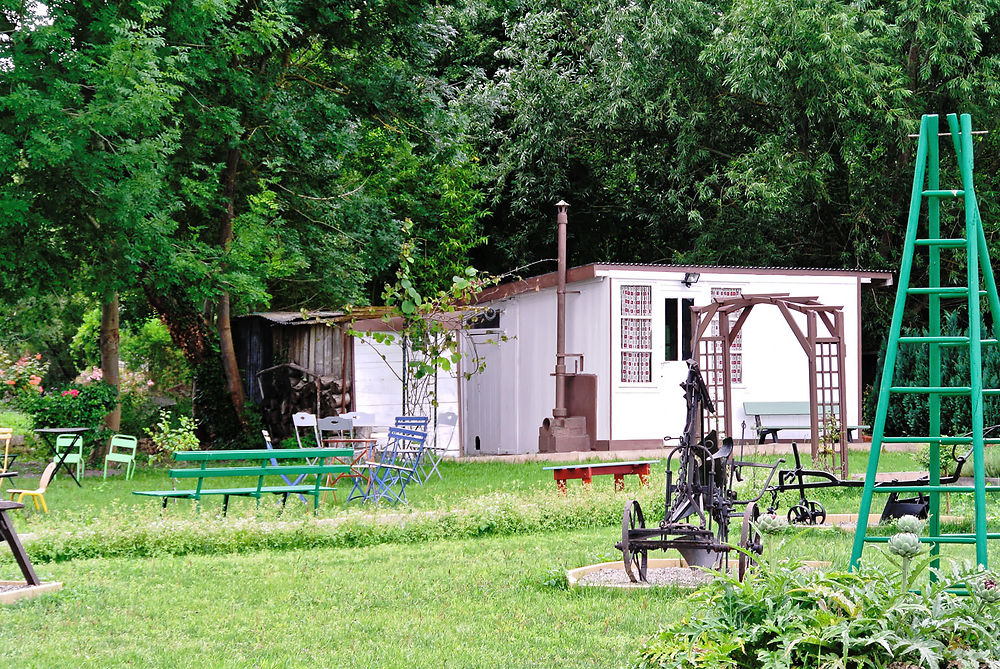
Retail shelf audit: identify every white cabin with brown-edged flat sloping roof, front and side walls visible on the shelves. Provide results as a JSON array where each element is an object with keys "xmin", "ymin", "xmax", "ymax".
[{"xmin": 458, "ymin": 264, "xmax": 892, "ymax": 455}]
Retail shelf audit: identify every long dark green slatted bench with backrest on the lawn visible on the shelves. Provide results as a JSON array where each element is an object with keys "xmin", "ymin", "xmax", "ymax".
[{"xmin": 132, "ymin": 448, "xmax": 354, "ymax": 516}]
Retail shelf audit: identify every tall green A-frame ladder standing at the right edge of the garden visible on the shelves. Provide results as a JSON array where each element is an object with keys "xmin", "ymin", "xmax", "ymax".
[{"xmin": 851, "ymin": 114, "xmax": 1000, "ymax": 569}]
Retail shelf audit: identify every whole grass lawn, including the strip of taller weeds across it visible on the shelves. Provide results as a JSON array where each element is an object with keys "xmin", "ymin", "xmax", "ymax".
[{"xmin": 7, "ymin": 444, "xmax": 996, "ymax": 667}]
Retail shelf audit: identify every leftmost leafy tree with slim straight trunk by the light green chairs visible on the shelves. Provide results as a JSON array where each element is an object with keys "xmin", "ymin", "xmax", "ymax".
[{"xmin": 0, "ymin": 1, "xmax": 180, "ymax": 438}]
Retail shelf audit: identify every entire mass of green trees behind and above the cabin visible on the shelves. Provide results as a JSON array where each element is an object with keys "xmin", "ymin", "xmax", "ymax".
[{"xmin": 0, "ymin": 0, "xmax": 1000, "ymax": 434}]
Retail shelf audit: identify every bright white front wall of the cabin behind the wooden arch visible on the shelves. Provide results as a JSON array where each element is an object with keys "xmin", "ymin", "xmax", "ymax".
[{"xmin": 610, "ymin": 271, "xmax": 860, "ymax": 441}]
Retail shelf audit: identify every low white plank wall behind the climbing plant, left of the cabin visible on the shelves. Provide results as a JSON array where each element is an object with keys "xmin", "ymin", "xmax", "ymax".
[{"xmin": 353, "ymin": 337, "xmax": 460, "ymax": 455}]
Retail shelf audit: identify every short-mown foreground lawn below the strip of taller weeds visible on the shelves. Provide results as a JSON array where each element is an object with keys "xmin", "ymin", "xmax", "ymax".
[{"xmin": 0, "ymin": 530, "xmax": 683, "ymax": 667}]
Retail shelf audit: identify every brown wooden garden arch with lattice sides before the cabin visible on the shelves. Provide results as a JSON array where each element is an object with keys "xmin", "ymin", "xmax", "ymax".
[{"xmin": 691, "ymin": 293, "xmax": 848, "ymax": 478}]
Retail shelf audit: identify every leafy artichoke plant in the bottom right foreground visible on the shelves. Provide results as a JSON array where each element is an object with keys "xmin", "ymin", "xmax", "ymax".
[{"xmin": 639, "ymin": 552, "xmax": 1000, "ymax": 669}]
